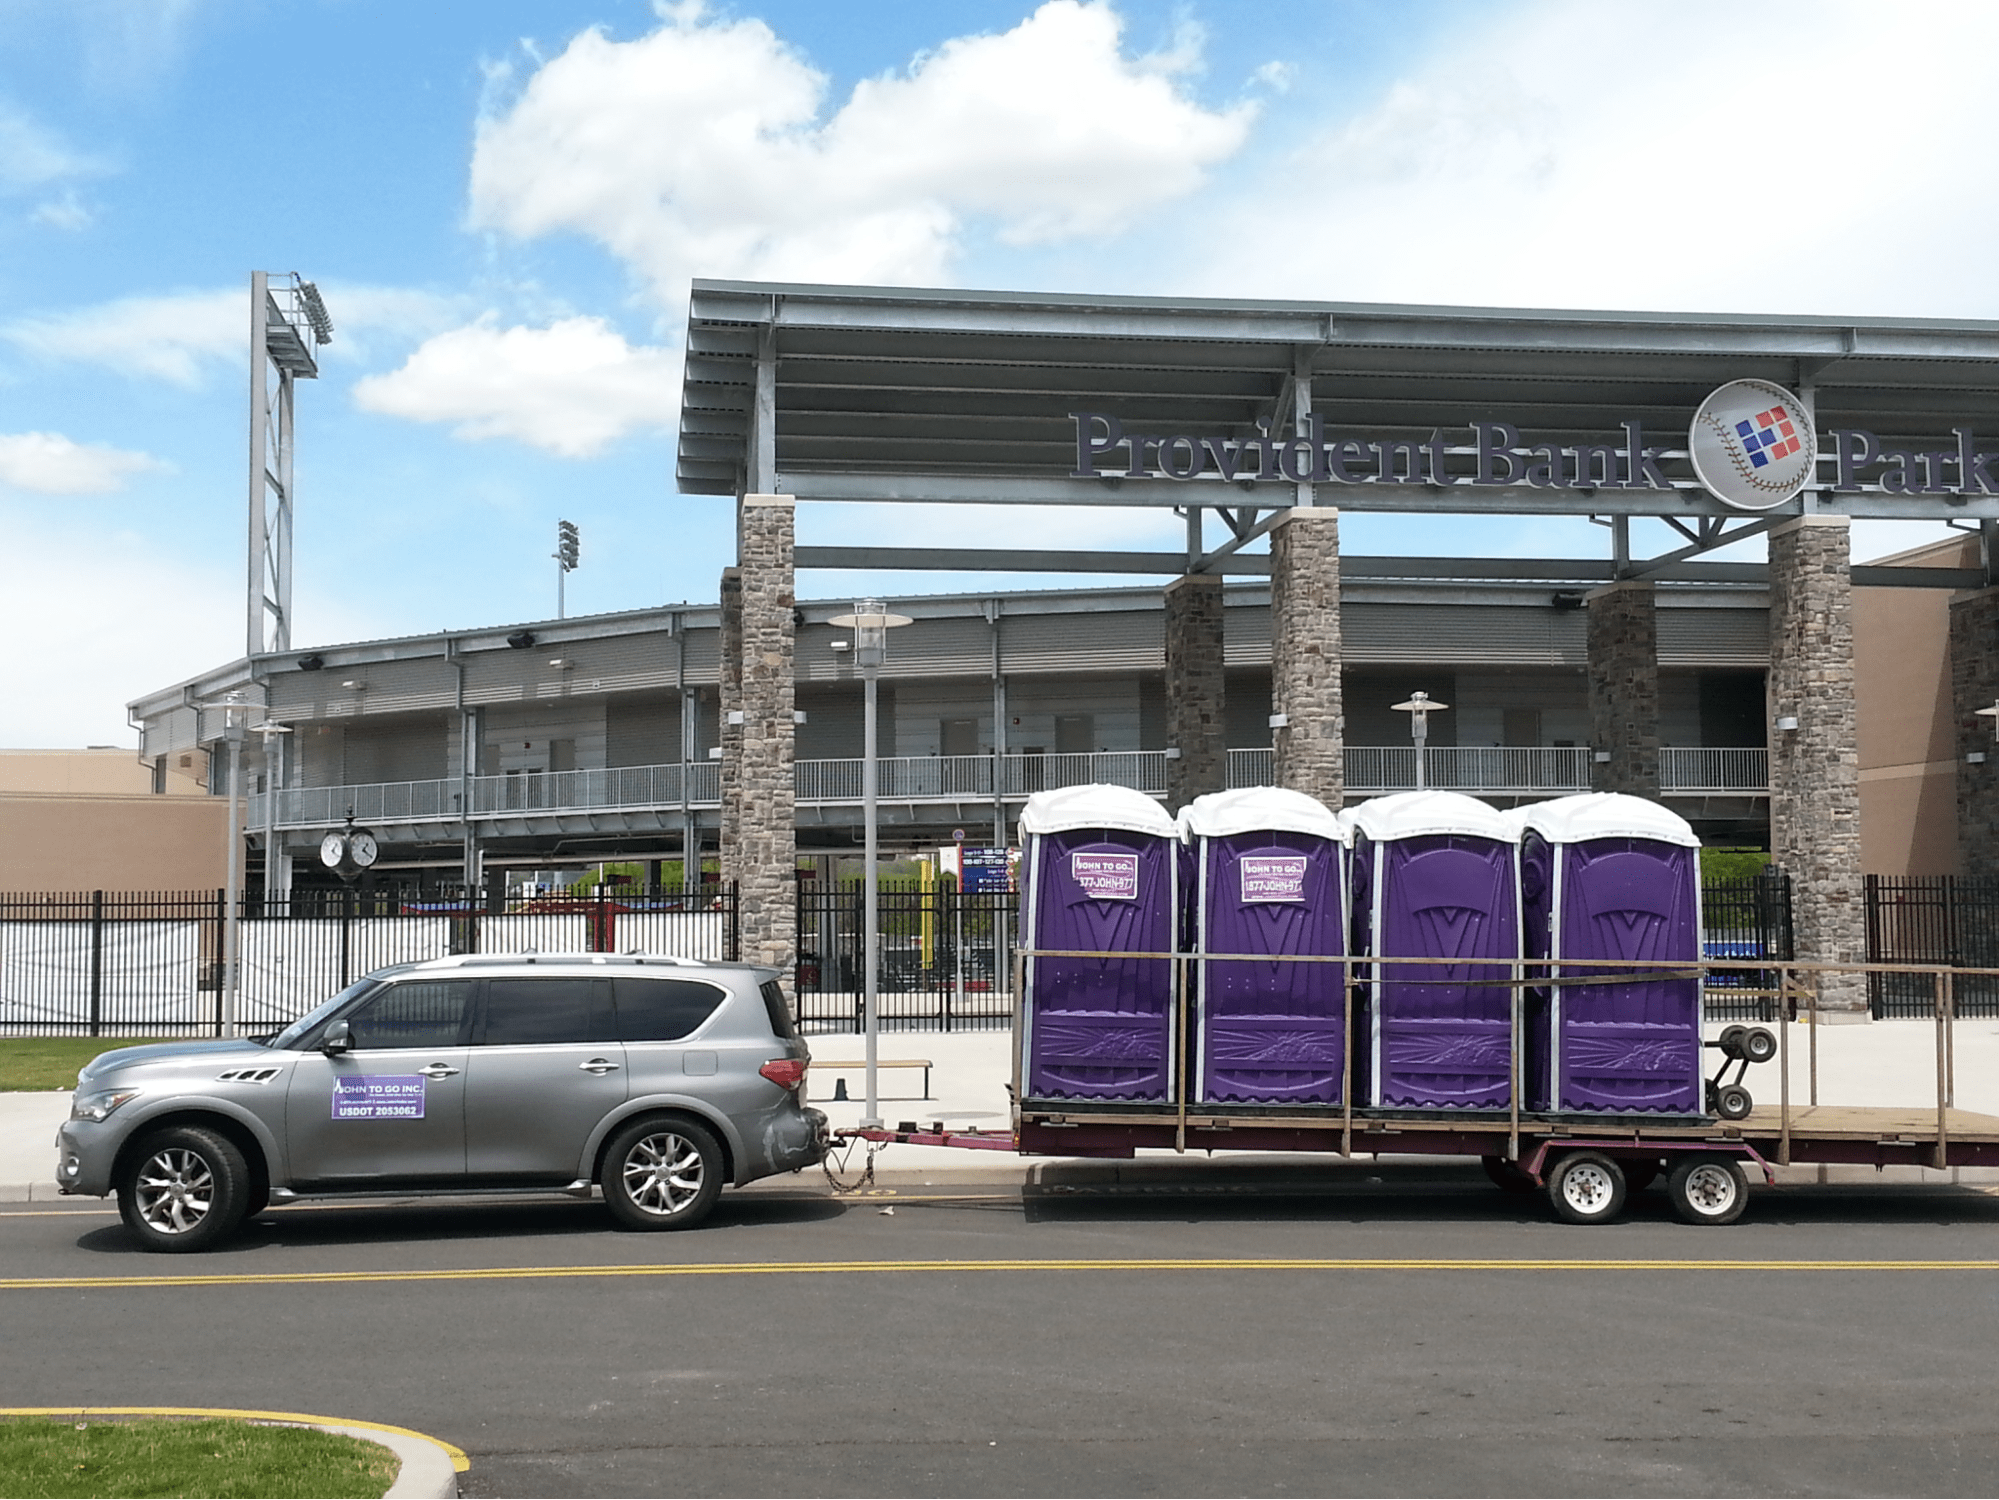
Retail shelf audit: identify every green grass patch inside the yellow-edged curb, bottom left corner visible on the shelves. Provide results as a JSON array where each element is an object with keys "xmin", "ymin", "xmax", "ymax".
[{"xmin": 0, "ymin": 1416, "xmax": 398, "ymax": 1500}]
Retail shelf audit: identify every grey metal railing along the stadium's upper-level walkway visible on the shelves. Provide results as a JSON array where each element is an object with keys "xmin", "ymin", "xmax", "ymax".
[{"xmin": 248, "ymin": 744, "xmax": 1769, "ymax": 828}]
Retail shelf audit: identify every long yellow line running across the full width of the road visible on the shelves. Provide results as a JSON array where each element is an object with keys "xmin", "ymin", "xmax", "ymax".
[{"xmin": 0, "ymin": 1258, "xmax": 1999, "ymax": 1292}]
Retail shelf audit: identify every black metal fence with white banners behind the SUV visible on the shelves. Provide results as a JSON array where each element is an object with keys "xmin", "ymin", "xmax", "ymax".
[{"xmin": 0, "ymin": 884, "xmax": 738, "ymax": 1036}]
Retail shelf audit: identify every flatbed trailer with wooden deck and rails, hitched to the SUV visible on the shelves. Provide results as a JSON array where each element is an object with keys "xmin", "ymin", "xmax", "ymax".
[{"xmin": 840, "ymin": 950, "xmax": 1999, "ymax": 1224}]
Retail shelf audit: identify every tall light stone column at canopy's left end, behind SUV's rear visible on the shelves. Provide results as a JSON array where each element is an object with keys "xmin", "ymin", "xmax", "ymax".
[{"xmin": 736, "ymin": 494, "xmax": 798, "ymax": 994}]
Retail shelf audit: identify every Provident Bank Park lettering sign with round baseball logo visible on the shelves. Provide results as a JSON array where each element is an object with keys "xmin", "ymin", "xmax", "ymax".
[{"xmin": 1069, "ymin": 380, "xmax": 1999, "ymax": 510}]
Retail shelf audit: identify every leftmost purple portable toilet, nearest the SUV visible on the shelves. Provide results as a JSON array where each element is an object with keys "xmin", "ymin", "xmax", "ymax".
[{"xmin": 1019, "ymin": 786, "xmax": 1179, "ymax": 1102}]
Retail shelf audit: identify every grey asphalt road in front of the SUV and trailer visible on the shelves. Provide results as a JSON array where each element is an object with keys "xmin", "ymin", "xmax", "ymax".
[{"xmin": 0, "ymin": 1164, "xmax": 1999, "ymax": 1496}]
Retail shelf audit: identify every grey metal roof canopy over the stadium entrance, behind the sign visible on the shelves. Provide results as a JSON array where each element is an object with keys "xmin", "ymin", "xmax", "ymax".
[{"xmin": 678, "ymin": 280, "xmax": 1999, "ymax": 582}]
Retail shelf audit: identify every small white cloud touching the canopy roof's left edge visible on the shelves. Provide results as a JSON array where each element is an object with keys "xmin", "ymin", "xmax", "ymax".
[{"xmin": 354, "ymin": 314, "xmax": 680, "ymax": 458}]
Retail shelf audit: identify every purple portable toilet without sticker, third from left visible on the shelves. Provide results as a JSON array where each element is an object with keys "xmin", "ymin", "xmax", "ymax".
[{"xmin": 1351, "ymin": 792, "xmax": 1521, "ymax": 1110}]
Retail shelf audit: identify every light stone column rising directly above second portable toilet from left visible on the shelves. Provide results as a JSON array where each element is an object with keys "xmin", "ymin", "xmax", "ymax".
[{"xmin": 1269, "ymin": 506, "xmax": 1347, "ymax": 810}]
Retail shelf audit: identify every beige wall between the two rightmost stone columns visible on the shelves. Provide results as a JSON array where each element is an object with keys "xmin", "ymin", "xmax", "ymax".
[{"xmin": 1853, "ymin": 538, "xmax": 1979, "ymax": 874}]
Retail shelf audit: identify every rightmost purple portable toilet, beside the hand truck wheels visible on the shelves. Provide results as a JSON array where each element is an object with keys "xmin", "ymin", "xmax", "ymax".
[{"xmin": 1517, "ymin": 792, "xmax": 1703, "ymax": 1114}]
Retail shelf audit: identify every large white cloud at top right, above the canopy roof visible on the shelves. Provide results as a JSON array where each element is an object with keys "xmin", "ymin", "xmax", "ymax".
[{"xmin": 1169, "ymin": 0, "xmax": 1999, "ymax": 316}]
